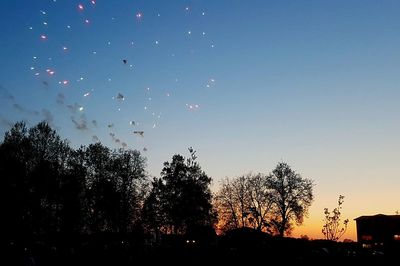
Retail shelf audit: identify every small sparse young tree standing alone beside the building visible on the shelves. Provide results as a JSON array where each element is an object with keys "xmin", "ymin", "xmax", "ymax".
[{"xmin": 322, "ymin": 195, "xmax": 349, "ymax": 241}]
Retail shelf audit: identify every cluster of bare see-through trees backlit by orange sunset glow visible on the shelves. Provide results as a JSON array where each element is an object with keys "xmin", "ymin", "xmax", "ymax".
[{"xmin": 214, "ymin": 169, "xmax": 313, "ymax": 236}]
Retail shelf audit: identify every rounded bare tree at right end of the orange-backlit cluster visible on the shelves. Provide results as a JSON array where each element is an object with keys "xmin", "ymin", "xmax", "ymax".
[{"xmin": 268, "ymin": 163, "xmax": 313, "ymax": 237}]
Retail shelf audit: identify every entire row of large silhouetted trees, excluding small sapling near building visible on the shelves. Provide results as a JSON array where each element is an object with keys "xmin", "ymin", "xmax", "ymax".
[{"xmin": 0, "ymin": 122, "xmax": 313, "ymax": 239}]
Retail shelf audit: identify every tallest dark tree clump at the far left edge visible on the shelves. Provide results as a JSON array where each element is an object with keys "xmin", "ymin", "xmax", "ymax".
[{"xmin": 0, "ymin": 122, "xmax": 75, "ymax": 235}]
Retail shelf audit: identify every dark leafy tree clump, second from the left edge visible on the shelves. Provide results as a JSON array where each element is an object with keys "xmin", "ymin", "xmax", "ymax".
[{"xmin": 80, "ymin": 143, "xmax": 147, "ymax": 233}]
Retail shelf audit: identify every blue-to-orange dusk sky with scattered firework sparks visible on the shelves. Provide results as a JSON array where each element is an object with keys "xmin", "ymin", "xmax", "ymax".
[{"xmin": 0, "ymin": 0, "xmax": 400, "ymax": 240}]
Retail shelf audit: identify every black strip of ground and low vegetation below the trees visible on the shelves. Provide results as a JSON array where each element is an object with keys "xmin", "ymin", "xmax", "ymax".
[{"xmin": 4, "ymin": 229, "xmax": 399, "ymax": 266}]
